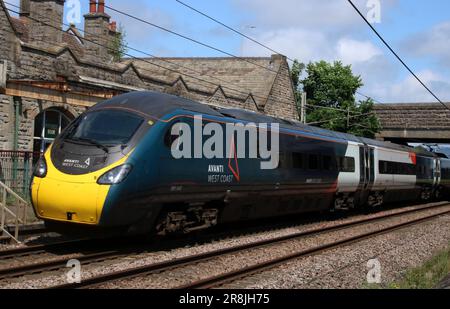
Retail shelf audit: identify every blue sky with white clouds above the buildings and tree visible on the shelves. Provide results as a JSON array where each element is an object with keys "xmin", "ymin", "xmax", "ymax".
[{"xmin": 5, "ymin": 0, "xmax": 450, "ymax": 103}]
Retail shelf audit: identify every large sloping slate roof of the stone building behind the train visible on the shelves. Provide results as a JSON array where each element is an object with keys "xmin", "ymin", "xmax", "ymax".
[{"xmin": 124, "ymin": 56, "xmax": 283, "ymax": 109}]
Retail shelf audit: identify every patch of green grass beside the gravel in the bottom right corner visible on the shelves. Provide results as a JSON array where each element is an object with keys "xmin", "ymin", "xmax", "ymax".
[{"xmin": 364, "ymin": 246, "xmax": 450, "ymax": 289}]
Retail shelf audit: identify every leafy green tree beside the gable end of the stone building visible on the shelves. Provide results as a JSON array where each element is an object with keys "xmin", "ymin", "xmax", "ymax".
[{"xmin": 291, "ymin": 61, "xmax": 381, "ymax": 138}]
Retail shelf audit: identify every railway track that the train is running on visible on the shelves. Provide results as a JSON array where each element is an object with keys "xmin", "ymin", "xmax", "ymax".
[{"xmin": 0, "ymin": 201, "xmax": 408, "ymax": 282}]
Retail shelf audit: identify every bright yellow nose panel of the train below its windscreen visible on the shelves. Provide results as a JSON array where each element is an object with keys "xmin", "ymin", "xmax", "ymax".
[{"xmin": 31, "ymin": 149, "xmax": 128, "ymax": 225}]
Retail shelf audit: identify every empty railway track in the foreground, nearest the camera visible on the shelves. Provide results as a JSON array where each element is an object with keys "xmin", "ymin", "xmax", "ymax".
[{"xmin": 46, "ymin": 203, "xmax": 450, "ymax": 289}]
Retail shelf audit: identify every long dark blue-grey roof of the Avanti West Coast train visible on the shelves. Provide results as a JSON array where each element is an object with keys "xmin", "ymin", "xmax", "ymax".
[{"xmin": 89, "ymin": 91, "xmax": 436, "ymax": 157}]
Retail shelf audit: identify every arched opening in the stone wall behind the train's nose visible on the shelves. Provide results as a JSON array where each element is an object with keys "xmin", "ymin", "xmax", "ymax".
[{"xmin": 33, "ymin": 108, "xmax": 73, "ymax": 153}]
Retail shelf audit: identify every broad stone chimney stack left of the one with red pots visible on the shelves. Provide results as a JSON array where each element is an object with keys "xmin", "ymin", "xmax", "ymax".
[{"xmin": 27, "ymin": 0, "xmax": 65, "ymax": 47}]
